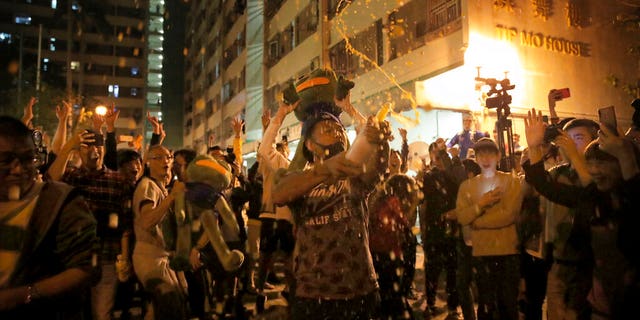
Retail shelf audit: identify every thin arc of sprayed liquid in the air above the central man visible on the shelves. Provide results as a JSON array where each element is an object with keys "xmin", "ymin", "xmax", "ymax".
[{"xmin": 333, "ymin": 0, "xmax": 420, "ymax": 128}]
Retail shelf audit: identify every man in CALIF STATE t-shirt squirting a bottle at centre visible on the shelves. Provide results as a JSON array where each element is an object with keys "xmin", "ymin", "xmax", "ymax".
[{"xmin": 272, "ymin": 109, "xmax": 389, "ymax": 319}]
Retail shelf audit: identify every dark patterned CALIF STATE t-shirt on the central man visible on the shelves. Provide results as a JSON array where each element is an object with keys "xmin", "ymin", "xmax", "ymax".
[{"xmin": 294, "ymin": 180, "xmax": 377, "ymax": 299}]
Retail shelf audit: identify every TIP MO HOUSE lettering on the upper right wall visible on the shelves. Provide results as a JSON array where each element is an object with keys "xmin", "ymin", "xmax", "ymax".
[{"xmin": 495, "ymin": 24, "xmax": 591, "ymax": 57}]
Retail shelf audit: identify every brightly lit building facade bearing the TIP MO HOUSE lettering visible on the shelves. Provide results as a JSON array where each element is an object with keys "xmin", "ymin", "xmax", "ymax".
[{"xmin": 185, "ymin": 0, "xmax": 640, "ymax": 162}]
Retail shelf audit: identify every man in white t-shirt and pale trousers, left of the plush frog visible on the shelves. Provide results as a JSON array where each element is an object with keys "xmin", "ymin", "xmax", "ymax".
[{"xmin": 133, "ymin": 145, "xmax": 187, "ymax": 319}]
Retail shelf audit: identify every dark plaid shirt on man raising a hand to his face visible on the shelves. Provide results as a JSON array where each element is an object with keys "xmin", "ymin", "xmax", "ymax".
[{"xmin": 63, "ymin": 167, "xmax": 133, "ymax": 260}]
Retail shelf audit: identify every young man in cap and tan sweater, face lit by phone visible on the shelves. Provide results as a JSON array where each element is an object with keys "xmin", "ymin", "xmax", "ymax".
[{"xmin": 456, "ymin": 138, "xmax": 521, "ymax": 320}]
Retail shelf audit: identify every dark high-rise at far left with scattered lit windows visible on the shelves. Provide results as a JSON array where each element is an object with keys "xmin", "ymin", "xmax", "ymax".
[{"xmin": 0, "ymin": 0, "xmax": 171, "ymax": 140}]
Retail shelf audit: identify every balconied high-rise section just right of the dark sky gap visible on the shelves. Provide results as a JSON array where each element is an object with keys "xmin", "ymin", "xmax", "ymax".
[{"xmin": 184, "ymin": 0, "xmax": 248, "ymax": 154}]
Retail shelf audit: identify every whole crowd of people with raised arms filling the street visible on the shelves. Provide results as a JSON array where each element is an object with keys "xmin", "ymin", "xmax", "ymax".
[{"xmin": 0, "ymin": 83, "xmax": 640, "ymax": 320}]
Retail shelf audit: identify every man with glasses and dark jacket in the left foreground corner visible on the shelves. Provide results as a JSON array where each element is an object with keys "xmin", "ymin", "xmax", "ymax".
[{"xmin": 0, "ymin": 116, "xmax": 97, "ymax": 319}]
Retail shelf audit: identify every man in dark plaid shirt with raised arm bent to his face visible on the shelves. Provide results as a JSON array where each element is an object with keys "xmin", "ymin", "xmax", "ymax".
[{"xmin": 47, "ymin": 130, "xmax": 133, "ymax": 319}]
